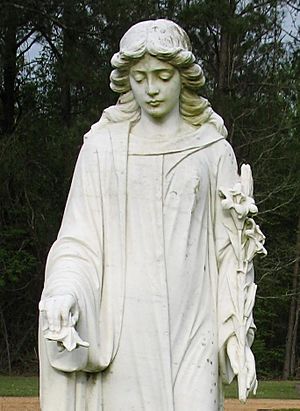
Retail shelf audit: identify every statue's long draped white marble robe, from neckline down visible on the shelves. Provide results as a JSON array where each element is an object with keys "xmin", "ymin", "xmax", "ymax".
[{"xmin": 40, "ymin": 122, "xmax": 254, "ymax": 411}]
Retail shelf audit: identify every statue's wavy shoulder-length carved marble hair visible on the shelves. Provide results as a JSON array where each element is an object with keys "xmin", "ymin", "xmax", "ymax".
[{"xmin": 100, "ymin": 19, "xmax": 227, "ymax": 136}]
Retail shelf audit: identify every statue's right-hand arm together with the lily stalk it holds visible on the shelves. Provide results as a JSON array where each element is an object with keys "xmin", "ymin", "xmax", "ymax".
[{"xmin": 215, "ymin": 142, "xmax": 265, "ymax": 401}]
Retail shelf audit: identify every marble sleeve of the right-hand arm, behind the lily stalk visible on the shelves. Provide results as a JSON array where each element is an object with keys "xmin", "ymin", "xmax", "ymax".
[{"xmin": 215, "ymin": 142, "xmax": 256, "ymax": 383}]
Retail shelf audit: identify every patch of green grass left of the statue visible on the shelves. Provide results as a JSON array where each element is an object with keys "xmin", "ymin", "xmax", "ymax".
[{"xmin": 0, "ymin": 375, "xmax": 39, "ymax": 397}]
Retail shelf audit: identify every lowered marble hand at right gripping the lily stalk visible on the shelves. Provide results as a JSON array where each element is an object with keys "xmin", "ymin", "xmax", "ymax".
[{"xmin": 227, "ymin": 335, "xmax": 258, "ymax": 395}]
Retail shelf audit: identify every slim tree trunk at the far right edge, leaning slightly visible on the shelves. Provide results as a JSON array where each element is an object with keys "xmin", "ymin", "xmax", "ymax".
[{"xmin": 282, "ymin": 216, "xmax": 300, "ymax": 380}]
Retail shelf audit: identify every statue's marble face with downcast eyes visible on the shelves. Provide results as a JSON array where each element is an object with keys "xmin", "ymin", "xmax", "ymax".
[{"xmin": 129, "ymin": 54, "xmax": 181, "ymax": 120}]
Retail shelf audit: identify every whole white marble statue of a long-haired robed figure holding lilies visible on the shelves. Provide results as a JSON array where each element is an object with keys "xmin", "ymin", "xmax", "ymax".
[{"xmin": 39, "ymin": 20, "xmax": 265, "ymax": 411}]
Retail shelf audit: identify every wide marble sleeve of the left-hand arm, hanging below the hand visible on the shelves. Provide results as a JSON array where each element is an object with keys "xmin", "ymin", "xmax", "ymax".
[{"xmin": 42, "ymin": 138, "xmax": 103, "ymax": 371}]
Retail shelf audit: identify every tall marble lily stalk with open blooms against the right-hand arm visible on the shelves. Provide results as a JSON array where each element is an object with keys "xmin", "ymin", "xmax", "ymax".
[{"xmin": 219, "ymin": 164, "xmax": 267, "ymax": 402}]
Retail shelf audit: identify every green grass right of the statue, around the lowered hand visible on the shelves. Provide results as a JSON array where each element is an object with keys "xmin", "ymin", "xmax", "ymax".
[{"xmin": 225, "ymin": 381, "xmax": 300, "ymax": 400}]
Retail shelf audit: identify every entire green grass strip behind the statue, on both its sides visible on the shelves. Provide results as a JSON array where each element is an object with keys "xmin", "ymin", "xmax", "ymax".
[{"xmin": 0, "ymin": 375, "xmax": 300, "ymax": 400}]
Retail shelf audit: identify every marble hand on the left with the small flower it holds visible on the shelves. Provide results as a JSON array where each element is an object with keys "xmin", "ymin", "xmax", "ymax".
[{"xmin": 39, "ymin": 295, "xmax": 89, "ymax": 351}]
